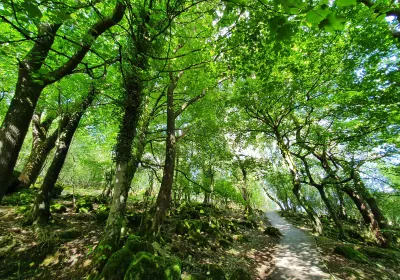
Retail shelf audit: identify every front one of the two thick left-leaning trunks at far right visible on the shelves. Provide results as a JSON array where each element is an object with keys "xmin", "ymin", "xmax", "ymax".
[{"xmin": 342, "ymin": 185, "xmax": 388, "ymax": 247}]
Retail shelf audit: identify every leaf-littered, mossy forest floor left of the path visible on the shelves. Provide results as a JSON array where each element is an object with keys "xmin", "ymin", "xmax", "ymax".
[{"xmin": 0, "ymin": 189, "xmax": 279, "ymax": 279}]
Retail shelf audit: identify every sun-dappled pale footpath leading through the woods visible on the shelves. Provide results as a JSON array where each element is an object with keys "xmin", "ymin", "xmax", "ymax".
[{"xmin": 266, "ymin": 212, "xmax": 330, "ymax": 280}]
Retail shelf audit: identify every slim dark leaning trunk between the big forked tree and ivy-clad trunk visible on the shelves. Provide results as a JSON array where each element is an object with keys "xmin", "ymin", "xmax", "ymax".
[{"xmin": 31, "ymin": 86, "xmax": 96, "ymax": 226}]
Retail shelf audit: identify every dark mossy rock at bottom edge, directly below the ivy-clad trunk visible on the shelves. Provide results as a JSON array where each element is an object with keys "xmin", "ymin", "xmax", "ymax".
[{"xmin": 98, "ymin": 248, "xmax": 135, "ymax": 280}]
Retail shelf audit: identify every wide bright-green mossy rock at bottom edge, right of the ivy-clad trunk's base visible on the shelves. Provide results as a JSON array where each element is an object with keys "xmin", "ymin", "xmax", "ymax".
[{"xmin": 124, "ymin": 252, "xmax": 181, "ymax": 280}]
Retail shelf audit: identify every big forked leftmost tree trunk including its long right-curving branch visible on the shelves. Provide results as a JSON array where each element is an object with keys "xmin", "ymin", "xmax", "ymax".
[{"xmin": 0, "ymin": 1, "xmax": 125, "ymax": 201}]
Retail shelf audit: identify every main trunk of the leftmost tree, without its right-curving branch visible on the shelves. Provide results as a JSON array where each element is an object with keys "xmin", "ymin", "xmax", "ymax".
[{"xmin": 0, "ymin": 24, "xmax": 60, "ymax": 201}]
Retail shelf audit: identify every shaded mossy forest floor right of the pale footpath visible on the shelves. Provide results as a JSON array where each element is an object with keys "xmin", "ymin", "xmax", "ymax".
[{"xmin": 280, "ymin": 212, "xmax": 400, "ymax": 280}]
